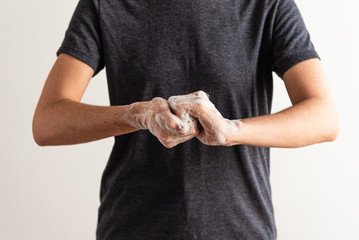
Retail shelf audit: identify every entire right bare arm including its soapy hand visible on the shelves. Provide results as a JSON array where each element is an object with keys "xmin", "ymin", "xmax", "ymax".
[{"xmin": 169, "ymin": 59, "xmax": 339, "ymax": 148}]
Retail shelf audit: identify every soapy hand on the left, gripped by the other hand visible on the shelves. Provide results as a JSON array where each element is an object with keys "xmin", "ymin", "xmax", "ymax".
[{"xmin": 127, "ymin": 97, "xmax": 199, "ymax": 148}]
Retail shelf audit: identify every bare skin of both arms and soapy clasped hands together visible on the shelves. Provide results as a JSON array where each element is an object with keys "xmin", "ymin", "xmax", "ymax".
[{"xmin": 33, "ymin": 53, "xmax": 339, "ymax": 148}]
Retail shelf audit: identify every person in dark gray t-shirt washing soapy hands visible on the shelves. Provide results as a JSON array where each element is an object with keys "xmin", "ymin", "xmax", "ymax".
[{"xmin": 33, "ymin": 0, "xmax": 339, "ymax": 240}]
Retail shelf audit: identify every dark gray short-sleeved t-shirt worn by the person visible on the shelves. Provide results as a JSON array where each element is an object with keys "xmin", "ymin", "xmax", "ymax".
[{"xmin": 57, "ymin": 0, "xmax": 319, "ymax": 240}]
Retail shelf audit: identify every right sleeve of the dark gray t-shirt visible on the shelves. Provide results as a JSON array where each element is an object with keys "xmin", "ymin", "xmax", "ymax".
[{"xmin": 272, "ymin": 0, "xmax": 320, "ymax": 79}]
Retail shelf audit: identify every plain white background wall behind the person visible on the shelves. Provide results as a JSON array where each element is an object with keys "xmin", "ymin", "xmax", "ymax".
[{"xmin": 0, "ymin": 0, "xmax": 359, "ymax": 240}]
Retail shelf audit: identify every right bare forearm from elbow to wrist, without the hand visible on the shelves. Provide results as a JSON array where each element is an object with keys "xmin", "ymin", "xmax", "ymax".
[{"xmin": 231, "ymin": 98, "xmax": 338, "ymax": 148}]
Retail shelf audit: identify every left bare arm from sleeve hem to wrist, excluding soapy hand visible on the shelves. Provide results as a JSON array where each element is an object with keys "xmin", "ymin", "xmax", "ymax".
[{"xmin": 33, "ymin": 54, "xmax": 138, "ymax": 146}]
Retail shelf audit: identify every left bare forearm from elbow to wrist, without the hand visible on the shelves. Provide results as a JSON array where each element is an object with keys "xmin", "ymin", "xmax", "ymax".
[{"xmin": 33, "ymin": 99, "xmax": 138, "ymax": 146}]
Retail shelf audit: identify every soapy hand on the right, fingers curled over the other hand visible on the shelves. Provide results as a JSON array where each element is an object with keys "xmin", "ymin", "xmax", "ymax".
[{"xmin": 168, "ymin": 91, "xmax": 242, "ymax": 146}]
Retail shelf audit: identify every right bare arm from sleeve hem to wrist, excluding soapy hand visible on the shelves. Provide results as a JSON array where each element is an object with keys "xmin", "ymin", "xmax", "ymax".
[{"xmin": 232, "ymin": 59, "xmax": 339, "ymax": 148}]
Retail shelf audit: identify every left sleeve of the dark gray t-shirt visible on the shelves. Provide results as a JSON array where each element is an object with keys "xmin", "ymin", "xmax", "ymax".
[{"xmin": 56, "ymin": 0, "xmax": 105, "ymax": 77}]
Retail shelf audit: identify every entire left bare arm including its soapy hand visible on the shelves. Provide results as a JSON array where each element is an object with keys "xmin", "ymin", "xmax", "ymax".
[{"xmin": 32, "ymin": 54, "xmax": 197, "ymax": 147}]
